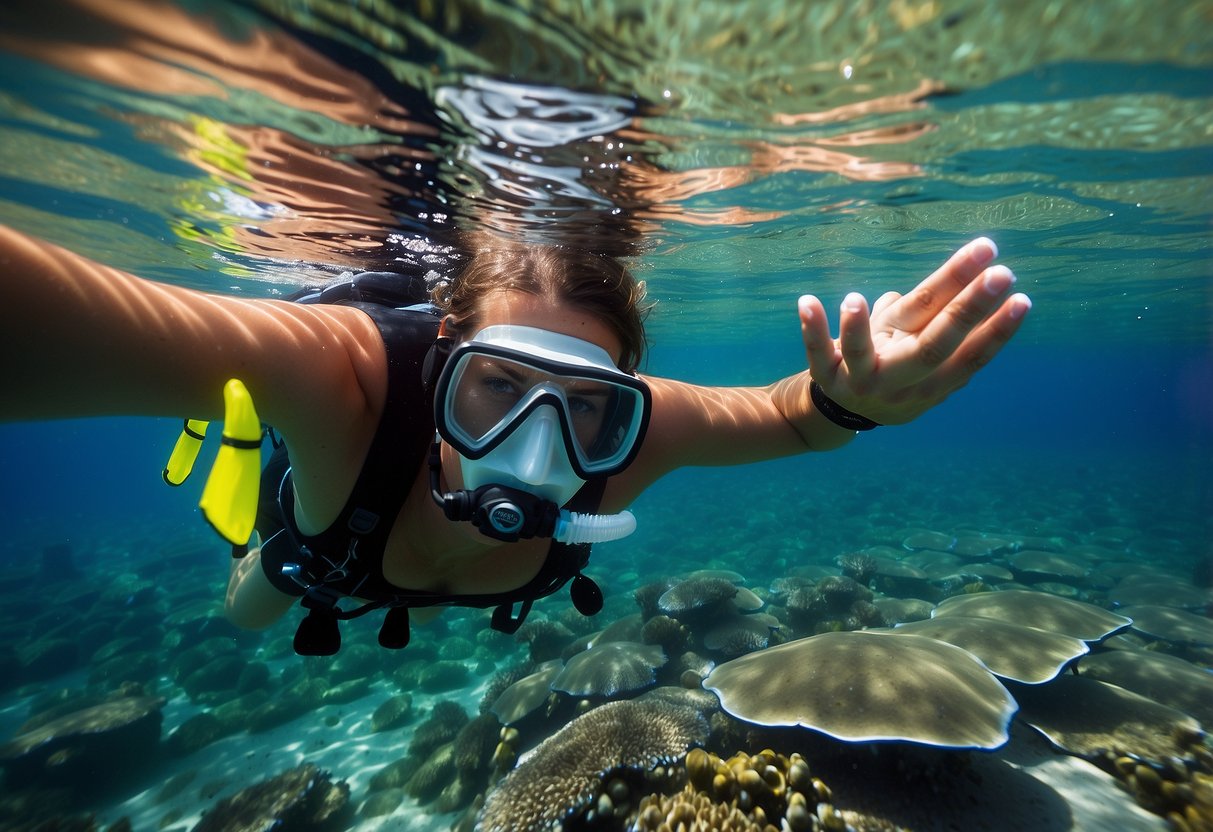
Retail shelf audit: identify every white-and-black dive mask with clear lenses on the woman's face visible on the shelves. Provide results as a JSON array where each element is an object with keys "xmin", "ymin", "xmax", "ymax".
[{"xmin": 434, "ymin": 325, "xmax": 651, "ymax": 506}]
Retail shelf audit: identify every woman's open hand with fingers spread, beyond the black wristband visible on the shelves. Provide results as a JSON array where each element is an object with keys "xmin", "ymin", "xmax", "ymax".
[{"xmin": 799, "ymin": 238, "xmax": 1032, "ymax": 424}]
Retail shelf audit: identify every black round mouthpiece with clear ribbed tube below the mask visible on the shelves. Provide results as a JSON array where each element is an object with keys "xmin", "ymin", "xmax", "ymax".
[{"xmin": 429, "ymin": 439, "xmax": 636, "ymax": 545}]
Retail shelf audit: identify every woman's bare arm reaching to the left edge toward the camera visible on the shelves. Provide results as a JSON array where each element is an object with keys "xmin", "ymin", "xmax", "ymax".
[{"xmin": 0, "ymin": 227, "xmax": 387, "ymax": 526}]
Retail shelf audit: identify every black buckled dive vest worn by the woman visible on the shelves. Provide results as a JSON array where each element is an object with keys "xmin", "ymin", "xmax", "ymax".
[{"xmin": 257, "ymin": 289, "xmax": 607, "ymax": 653}]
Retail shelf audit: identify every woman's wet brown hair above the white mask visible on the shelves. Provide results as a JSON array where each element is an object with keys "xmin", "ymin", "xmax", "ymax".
[{"xmin": 433, "ymin": 232, "xmax": 649, "ymax": 372}]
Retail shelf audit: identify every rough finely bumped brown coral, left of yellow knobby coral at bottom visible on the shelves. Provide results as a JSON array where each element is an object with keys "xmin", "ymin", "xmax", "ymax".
[{"xmin": 477, "ymin": 700, "xmax": 707, "ymax": 832}]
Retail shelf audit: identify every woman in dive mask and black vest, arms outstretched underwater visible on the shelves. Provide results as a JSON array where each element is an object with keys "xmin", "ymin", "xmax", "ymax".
[{"xmin": 0, "ymin": 228, "xmax": 1031, "ymax": 653}]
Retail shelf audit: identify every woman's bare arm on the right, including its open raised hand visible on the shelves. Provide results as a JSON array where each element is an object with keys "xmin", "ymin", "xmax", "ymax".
[{"xmin": 610, "ymin": 238, "xmax": 1031, "ymax": 502}]
